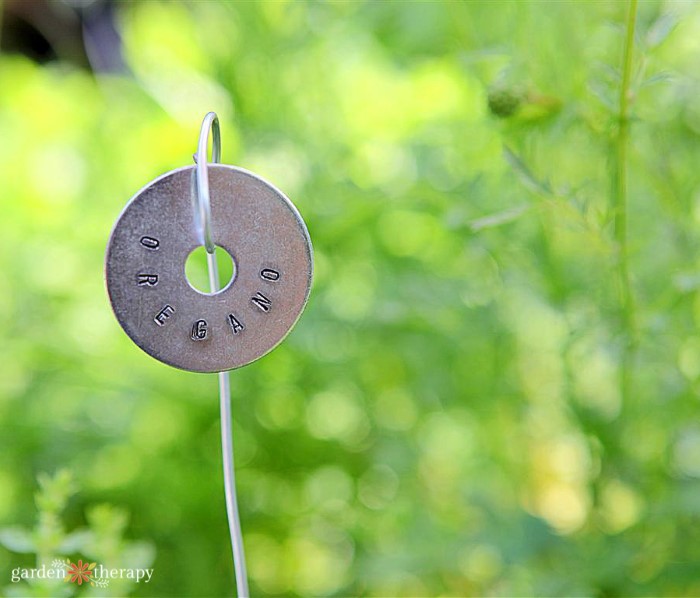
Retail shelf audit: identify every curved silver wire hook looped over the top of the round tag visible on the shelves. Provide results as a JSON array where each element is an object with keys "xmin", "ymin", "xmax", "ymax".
[{"xmin": 194, "ymin": 112, "xmax": 221, "ymax": 253}]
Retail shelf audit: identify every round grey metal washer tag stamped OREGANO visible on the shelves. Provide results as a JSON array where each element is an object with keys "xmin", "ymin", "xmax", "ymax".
[{"xmin": 106, "ymin": 164, "xmax": 313, "ymax": 372}]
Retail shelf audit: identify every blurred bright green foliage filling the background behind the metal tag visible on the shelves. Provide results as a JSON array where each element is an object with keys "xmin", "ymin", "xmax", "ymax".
[{"xmin": 0, "ymin": 1, "xmax": 700, "ymax": 596}]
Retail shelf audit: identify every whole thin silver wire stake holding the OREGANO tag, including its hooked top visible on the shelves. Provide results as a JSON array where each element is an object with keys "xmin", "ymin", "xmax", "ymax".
[{"xmin": 195, "ymin": 112, "xmax": 250, "ymax": 598}]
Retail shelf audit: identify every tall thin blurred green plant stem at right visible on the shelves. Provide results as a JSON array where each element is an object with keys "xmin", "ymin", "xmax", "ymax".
[{"xmin": 611, "ymin": 0, "xmax": 637, "ymax": 410}]
